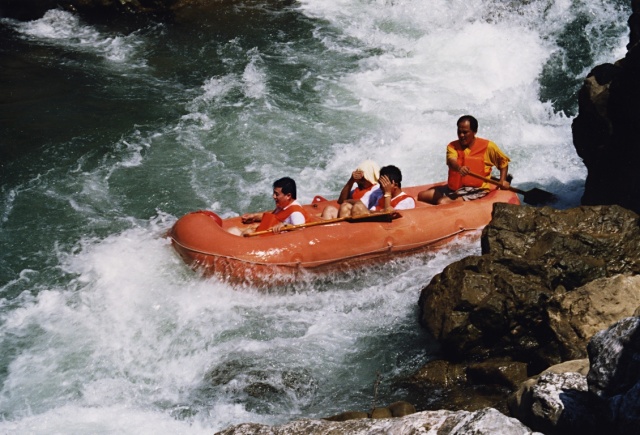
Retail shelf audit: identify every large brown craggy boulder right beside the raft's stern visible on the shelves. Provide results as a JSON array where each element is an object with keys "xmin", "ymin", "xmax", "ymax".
[{"xmin": 419, "ymin": 204, "xmax": 640, "ymax": 373}]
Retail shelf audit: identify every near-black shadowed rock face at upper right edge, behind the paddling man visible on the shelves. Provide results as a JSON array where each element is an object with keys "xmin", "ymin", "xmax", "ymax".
[{"xmin": 572, "ymin": 0, "xmax": 640, "ymax": 213}]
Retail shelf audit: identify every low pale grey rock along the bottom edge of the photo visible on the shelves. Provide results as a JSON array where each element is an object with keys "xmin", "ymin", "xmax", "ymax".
[{"xmin": 218, "ymin": 408, "xmax": 534, "ymax": 435}]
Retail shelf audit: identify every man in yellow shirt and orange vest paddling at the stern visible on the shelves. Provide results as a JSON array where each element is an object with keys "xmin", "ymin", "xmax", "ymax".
[{"xmin": 418, "ymin": 115, "xmax": 510, "ymax": 205}]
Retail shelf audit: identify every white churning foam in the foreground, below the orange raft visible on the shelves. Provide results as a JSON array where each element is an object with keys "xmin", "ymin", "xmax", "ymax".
[{"xmin": 0, "ymin": 217, "xmax": 464, "ymax": 433}]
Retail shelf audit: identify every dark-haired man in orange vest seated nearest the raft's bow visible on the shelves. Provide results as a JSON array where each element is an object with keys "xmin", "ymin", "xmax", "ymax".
[{"xmin": 229, "ymin": 177, "xmax": 311, "ymax": 235}]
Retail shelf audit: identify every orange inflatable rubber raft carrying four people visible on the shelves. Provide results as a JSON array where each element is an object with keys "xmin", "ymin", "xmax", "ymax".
[{"xmin": 168, "ymin": 183, "xmax": 520, "ymax": 287}]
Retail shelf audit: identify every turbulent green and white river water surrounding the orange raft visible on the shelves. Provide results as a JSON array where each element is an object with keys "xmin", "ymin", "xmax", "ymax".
[{"xmin": 0, "ymin": 0, "xmax": 630, "ymax": 434}]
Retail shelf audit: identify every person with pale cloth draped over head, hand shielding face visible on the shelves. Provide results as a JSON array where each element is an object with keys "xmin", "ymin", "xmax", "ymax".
[{"xmin": 322, "ymin": 160, "xmax": 380, "ymax": 219}]
